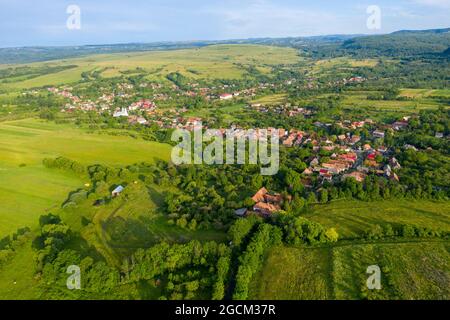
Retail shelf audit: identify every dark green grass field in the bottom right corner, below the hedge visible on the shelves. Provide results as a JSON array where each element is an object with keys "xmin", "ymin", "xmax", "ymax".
[{"xmin": 251, "ymin": 242, "xmax": 450, "ymax": 300}]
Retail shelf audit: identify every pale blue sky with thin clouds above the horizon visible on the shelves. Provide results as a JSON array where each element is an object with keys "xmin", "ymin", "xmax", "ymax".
[{"xmin": 0, "ymin": 0, "xmax": 450, "ymax": 47}]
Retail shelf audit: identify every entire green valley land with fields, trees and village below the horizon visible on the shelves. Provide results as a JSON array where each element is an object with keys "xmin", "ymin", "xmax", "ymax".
[{"xmin": 0, "ymin": 28, "xmax": 450, "ymax": 300}]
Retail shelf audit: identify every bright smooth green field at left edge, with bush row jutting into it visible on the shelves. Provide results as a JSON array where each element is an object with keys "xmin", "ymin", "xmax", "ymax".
[{"xmin": 0, "ymin": 119, "xmax": 170, "ymax": 236}]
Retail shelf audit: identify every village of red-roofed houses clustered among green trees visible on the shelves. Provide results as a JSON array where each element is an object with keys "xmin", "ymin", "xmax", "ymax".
[{"xmin": 44, "ymin": 77, "xmax": 415, "ymax": 208}]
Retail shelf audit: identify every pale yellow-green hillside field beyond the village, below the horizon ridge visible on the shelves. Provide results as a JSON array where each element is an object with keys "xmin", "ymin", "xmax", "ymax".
[{"xmin": 0, "ymin": 45, "xmax": 299, "ymax": 89}]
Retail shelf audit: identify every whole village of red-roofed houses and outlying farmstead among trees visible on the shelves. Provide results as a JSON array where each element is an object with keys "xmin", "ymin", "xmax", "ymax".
[{"xmin": 42, "ymin": 77, "xmax": 443, "ymax": 224}]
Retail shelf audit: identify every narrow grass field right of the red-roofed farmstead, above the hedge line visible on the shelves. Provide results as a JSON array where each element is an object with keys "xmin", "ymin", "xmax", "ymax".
[{"xmin": 305, "ymin": 200, "xmax": 450, "ymax": 238}]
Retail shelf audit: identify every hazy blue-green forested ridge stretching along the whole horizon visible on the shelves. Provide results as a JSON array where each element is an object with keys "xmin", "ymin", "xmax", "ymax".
[{"xmin": 0, "ymin": 28, "xmax": 450, "ymax": 64}]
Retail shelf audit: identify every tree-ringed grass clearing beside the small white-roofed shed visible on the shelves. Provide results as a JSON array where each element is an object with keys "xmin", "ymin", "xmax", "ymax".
[{"xmin": 60, "ymin": 181, "xmax": 226, "ymax": 265}]
